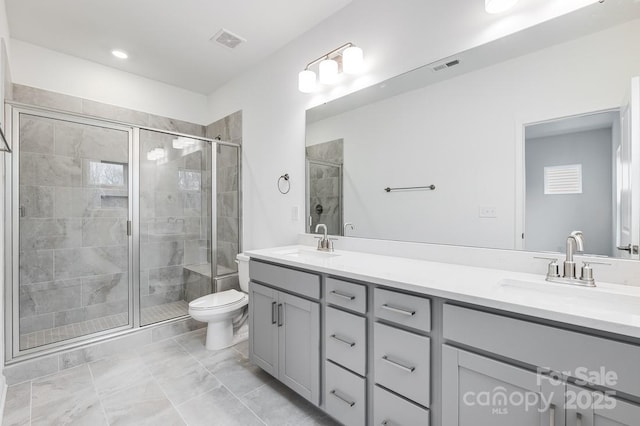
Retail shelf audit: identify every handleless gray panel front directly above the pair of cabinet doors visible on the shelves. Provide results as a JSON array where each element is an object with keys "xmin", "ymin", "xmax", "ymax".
[{"xmin": 249, "ymin": 259, "xmax": 320, "ymax": 300}]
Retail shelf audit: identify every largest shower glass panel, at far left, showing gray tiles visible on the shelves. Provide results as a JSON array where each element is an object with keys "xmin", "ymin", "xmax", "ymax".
[{"xmin": 12, "ymin": 110, "xmax": 132, "ymax": 351}]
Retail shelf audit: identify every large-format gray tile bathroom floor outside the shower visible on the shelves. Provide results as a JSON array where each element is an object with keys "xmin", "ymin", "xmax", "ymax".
[{"xmin": 2, "ymin": 329, "xmax": 336, "ymax": 426}]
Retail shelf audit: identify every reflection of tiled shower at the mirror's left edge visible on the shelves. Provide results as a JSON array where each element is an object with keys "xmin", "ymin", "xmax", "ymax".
[{"xmin": 306, "ymin": 139, "xmax": 344, "ymax": 235}]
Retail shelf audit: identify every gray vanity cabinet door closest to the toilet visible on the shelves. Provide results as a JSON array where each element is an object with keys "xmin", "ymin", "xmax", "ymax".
[{"xmin": 249, "ymin": 282, "xmax": 278, "ymax": 377}]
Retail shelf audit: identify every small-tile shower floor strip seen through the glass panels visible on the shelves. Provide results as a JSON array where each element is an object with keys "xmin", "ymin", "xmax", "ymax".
[{"xmin": 20, "ymin": 300, "xmax": 189, "ymax": 350}]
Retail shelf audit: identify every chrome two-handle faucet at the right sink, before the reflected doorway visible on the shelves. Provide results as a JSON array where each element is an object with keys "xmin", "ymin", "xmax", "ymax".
[{"xmin": 536, "ymin": 231, "xmax": 609, "ymax": 287}]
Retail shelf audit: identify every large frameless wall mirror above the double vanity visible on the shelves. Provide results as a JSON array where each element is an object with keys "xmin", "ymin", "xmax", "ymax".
[{"xmin": 306, "ymin": 1, "xmax": 640, "ymax": 259}]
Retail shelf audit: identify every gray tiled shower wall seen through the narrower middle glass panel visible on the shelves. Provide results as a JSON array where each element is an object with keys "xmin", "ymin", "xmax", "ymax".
[{"xmin": 140, "ymin": 130, "xmax": 211, "ymax": 309}]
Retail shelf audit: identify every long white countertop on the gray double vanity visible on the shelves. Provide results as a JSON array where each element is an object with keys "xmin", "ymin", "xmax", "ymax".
[{"xmin": 245, "ymin": 245, "xmax": 640, "ymax": 338}]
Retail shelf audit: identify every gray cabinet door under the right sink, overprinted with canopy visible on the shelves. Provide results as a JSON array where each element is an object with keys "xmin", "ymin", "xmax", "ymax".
[{"xmin": 442, "ymin": 346, "xmax": 565, "ymax": 426}]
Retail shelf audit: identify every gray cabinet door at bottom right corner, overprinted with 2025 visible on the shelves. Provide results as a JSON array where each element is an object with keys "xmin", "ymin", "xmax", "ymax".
[{"xmin": 566, "ymin": 386, "xmax": 640, "ymax": 426}]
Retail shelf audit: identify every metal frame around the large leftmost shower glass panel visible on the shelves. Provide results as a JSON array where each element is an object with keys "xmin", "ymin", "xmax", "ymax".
[{"xmin": 4, "ymin": 103, "xmax": 139, "ymax": 362}]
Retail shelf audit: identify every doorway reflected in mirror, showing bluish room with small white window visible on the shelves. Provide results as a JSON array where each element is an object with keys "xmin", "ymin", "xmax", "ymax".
[{"xmin": 524, "ymin": 110, "xmax": 620, "ymax": 256}]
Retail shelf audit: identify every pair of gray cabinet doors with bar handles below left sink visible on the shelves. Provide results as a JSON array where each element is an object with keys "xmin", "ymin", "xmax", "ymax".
[{"xmin": 249, "ymin": 281, "xmax": 320, "ymax": 405}]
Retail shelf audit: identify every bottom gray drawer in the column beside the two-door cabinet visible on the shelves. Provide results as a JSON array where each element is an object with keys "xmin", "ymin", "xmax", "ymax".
[{"xmin": 324, "ymin": 361, "xmax": 366, "ymax": 426}]
